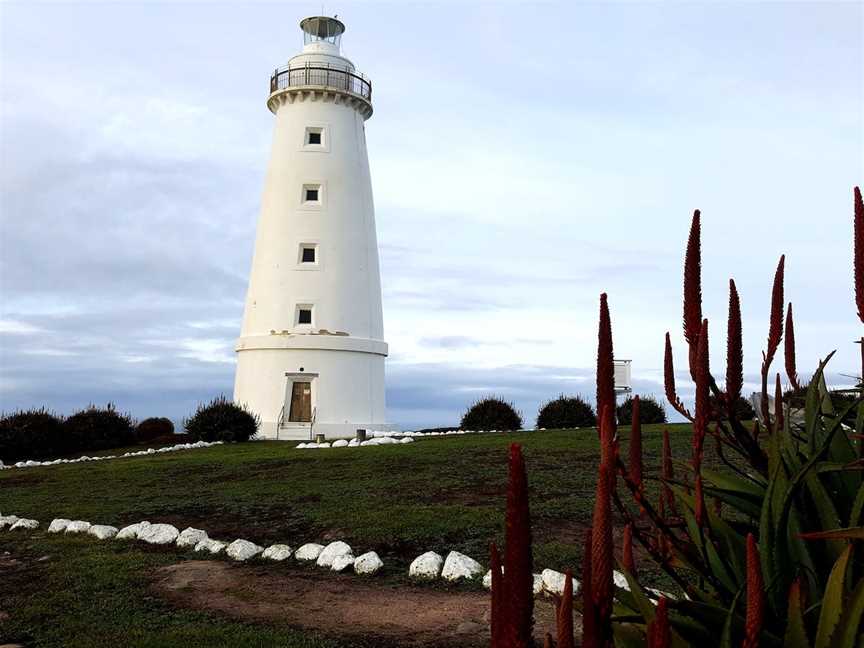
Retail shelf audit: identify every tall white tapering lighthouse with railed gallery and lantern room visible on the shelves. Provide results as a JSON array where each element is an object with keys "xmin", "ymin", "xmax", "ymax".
[{"xmin": 234, "ymin": 16, "xmax": 387, "ymax": 439}]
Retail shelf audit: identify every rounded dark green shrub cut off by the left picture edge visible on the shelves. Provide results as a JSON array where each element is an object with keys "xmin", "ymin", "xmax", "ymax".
[{"xmin": 0, "ymin": 408, "xmax": 68, "ymax": 463}]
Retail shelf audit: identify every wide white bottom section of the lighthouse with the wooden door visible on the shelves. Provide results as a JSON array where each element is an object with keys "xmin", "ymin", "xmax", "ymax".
[{"xmin": 234, "ymin": 338, "xmax": 393, "ymax": 440}]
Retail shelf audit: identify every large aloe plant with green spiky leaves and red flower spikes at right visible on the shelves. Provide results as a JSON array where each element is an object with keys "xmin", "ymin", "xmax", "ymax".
[{"xmin": 493, "ymin": 188, "xmax": 864, "ymax": 648}]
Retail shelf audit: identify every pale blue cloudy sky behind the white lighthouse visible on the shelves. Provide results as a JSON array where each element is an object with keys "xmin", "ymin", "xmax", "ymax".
[{"xmin": 0, "ymin": 1, "xmax": 864, "ymax": 428}]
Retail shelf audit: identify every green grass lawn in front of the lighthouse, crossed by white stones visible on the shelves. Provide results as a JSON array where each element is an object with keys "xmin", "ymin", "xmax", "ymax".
[{"xmin": 0, "ymin": 425, "xmax": 690, "ymax": 647}]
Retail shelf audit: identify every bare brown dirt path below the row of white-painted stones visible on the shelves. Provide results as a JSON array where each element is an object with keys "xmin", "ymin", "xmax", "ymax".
[{"xmin": 153, "ymin": 561, "xmax": 554, "ymax": 648}]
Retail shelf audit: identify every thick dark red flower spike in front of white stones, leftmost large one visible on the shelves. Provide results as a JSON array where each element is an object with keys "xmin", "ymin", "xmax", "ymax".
[{"xmin": 502, "ymin": 443, "xmax": 534, "ymax": 646}]
